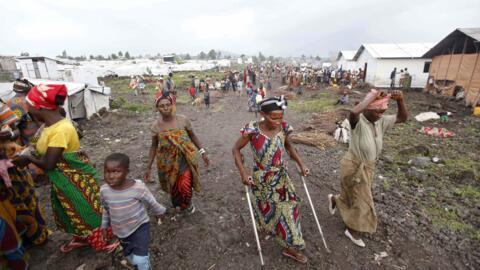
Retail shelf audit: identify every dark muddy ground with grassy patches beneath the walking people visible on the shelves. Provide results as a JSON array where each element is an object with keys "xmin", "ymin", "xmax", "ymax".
[{"xmin": 30, "ymin": 76, "xmax": 480, "ymax": 270}]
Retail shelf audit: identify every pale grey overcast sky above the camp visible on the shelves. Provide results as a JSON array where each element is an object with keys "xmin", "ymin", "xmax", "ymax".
[{"xmin": 0, "ymin": 0, "xmax": 480, "ymax": 56}]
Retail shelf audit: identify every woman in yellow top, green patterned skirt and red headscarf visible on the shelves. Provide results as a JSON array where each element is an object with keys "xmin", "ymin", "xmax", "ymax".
[{"xmin": 15, "ymin": 84, "xmax": 118, "ymax": 252}]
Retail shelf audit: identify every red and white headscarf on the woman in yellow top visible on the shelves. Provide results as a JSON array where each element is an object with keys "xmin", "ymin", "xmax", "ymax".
[{"xmin": 27, "ymin": 84, "xmax": 67, "ymax": 110}]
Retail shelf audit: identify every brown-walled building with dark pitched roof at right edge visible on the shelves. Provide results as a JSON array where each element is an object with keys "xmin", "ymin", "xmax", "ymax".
[{"xmin": 424, "ymin": 28, "xmax": 480, "ymax": 106}]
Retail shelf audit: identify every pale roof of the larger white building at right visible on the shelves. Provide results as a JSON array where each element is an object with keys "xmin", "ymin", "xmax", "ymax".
[{"xmin": 354, "ymin": 43, "xmax": 435, "ymax": 60}]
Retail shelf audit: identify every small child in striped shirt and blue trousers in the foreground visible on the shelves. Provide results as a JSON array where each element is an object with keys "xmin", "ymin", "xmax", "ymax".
[{"xmin": 100, "ymin": 153, "xmax": 166, "ymax": 270}]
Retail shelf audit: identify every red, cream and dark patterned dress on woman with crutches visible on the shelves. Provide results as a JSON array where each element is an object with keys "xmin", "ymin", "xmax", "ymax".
[{"xmin": 241, "ymin": 121, "xmax": 305, "ymax": 250}]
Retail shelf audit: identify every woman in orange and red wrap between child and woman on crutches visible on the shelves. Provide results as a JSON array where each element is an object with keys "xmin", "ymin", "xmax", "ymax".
[{"xmin": 144, "ymin": 95, "xmax": 209, "ymax": 213}]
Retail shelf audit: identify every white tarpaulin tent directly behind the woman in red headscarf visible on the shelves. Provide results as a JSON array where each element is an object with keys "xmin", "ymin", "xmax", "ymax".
[{"xmin": 0, "ymin": 79, "xmax": 111, "ymax": 119}]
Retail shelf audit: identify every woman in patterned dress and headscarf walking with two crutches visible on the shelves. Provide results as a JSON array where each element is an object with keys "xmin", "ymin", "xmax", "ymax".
[{"xmin": 232, "ymin": 96, "xmax": 309, "ymax": 263}]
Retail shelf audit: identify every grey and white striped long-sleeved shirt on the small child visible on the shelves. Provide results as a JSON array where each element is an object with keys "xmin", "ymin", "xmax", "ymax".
[{"xmin": 100, "ymin": 180, "xmax": 166, "ymax": 238}]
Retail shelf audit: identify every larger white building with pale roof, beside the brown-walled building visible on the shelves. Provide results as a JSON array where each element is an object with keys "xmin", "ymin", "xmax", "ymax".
[{"xmin": 353, "ymin": 43, "xmax": 435, "ymax": 88}]
